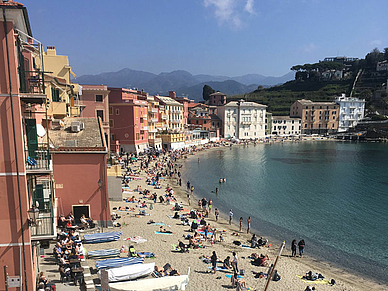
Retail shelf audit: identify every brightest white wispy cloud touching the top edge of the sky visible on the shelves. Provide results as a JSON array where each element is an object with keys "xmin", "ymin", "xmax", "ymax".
[{"xmin": 203, "ymin": 0, "xmax": 256, "ymax": 29}]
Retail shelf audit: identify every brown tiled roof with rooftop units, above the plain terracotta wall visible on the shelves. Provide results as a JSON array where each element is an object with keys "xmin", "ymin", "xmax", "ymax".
[{"xmin": 49, "ymin": 117, "xmax": 106, "ymax": 153}]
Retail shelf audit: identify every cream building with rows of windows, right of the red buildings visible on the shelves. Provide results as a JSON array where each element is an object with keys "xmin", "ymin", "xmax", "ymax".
[{"xmin": 155, "ymin": 95, "xmax": 184, "ymax": 133}]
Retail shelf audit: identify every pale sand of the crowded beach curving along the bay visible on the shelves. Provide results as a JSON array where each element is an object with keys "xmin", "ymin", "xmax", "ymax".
[{"xmin": 85, "ymin": 144, "xmax": 387, "ymax": 291}]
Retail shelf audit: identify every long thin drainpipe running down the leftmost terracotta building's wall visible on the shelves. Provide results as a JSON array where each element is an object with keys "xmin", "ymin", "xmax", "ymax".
[{"xmin": 3, "ymin": 7, "xmax": 28, "ymax": 291}]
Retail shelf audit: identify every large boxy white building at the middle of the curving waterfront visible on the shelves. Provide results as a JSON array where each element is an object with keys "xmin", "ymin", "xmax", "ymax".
[{"xmin": 217, "ymin": 100, "xmax": 267, "ymax": 139}]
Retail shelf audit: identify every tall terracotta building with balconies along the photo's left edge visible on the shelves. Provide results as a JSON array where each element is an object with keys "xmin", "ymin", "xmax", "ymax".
[{"xmin": 0, "ymin": 1, "xmax": 56, "ymax": 290}]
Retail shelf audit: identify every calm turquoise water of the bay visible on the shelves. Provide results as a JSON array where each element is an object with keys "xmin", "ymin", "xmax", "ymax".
[{"xmin": 183, "ymin": 142, "xmax": 388, "ymax": 282}]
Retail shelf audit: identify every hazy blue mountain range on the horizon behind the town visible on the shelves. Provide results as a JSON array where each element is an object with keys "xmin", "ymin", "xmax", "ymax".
[{"xmin": 74, "ymin": 68, "xmax": 294, "ymax": 101}]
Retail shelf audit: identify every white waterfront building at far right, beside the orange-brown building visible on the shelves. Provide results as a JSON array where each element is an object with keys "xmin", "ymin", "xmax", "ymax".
[{"xmin": 335, "ymin": 94, "xmax": 365, "ymax": 132}]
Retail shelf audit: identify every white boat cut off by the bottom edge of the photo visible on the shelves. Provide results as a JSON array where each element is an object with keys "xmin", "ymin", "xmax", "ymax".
[{"xmin": 109, "ymin": 275, "xmax": 189, "ymax": 291}]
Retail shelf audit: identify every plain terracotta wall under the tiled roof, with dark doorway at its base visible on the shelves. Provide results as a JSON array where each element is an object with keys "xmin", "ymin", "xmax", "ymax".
[{"xmin": 53, "ymin": 153, "xmax": 110, "ymax": 227}]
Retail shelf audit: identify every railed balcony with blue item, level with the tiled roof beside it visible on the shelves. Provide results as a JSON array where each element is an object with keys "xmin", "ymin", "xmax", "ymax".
[{"xmin": 24, "ymin": 143, "xmax": 52, "ymax": 174}]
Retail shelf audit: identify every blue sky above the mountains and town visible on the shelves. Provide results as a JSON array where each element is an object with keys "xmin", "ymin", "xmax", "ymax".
[{"xmin": 19, "ymin": 0, "xmax": 388, "ymax": 77}]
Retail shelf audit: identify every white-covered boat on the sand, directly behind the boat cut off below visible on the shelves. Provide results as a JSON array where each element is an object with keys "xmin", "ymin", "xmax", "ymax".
[{"xmin": 99, "ymin": 263, "xmax": 155, "ymax": 282}]
